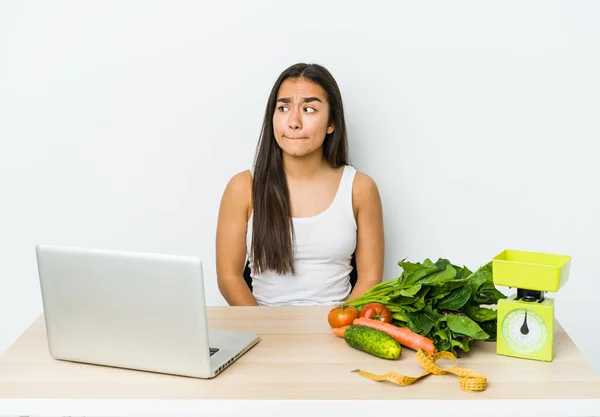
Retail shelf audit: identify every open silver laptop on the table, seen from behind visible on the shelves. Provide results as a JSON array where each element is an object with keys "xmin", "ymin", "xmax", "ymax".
[{"xmin": 36, "ymin": 245, "xmax": 260, "ymax": 378}]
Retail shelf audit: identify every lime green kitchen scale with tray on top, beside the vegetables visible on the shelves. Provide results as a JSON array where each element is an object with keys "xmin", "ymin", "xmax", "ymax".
[{"xmin": 492, "ymin": 249, "xmax": 571, "ymax": 362}]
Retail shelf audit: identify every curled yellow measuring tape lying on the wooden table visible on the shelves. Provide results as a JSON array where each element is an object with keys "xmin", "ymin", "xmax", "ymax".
[{"xmin": 351, "ymin": 349, "xmax": 487, "ymax": 392}]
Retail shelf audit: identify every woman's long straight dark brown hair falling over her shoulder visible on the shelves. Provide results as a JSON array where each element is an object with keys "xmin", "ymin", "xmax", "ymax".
[{"xmin": 252, "ymin": 63, "xmax": 348, "ymax": 274}]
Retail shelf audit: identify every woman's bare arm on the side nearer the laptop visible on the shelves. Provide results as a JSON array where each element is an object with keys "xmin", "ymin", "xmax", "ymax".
[{"xmin": 216, "ymin": 171, "xmax": 258, "ymax": 306}]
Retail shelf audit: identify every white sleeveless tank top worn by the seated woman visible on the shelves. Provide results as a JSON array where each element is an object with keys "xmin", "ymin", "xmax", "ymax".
[{"xmin": 246, "ymin": 165, "xmax": 357, "ymax": 306}]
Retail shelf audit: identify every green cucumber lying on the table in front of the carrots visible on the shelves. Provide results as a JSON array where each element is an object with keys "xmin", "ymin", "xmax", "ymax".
[{"xmin": 344, "ymin": 325, "xmax": 402, "ymax": 359}]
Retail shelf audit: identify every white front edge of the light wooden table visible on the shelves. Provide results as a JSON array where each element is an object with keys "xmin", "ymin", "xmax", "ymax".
[{"xmin": 0, "ymin": 394, "xmax": 600, "ymax": 417}]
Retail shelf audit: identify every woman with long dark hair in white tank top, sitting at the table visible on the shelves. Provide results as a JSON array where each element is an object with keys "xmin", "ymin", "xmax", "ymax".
[{"xmin": 216, "ymin": 64, "xmax": 384, "ymax": 306}]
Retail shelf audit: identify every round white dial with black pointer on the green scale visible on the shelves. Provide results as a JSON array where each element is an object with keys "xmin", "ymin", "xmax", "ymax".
[{"xmin": 502, "ymin": 308, "xmax": 548, "ymax": 354}]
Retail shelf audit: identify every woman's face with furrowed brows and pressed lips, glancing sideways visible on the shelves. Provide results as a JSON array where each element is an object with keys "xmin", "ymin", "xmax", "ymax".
[{"xmin": 273, "ymin": 78, "xmax": 334, "ymax": 157}]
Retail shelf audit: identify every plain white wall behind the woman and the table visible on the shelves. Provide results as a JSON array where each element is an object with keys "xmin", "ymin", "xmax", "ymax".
[{"xmin": 0, "ymin": 0, "xmax": 600, "ymax": 371}]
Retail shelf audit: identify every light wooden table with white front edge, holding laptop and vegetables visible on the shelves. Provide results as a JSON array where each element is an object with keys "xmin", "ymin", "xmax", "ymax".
[{"xmin": 0, "ymin": 307, "xmax": 600, "ymax": 417}]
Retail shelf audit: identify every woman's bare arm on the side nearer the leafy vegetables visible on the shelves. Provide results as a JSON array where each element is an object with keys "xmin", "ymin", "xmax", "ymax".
[{"xmin": 348, "ymin": 172, "xmax": 385, "ymax": 299}]
